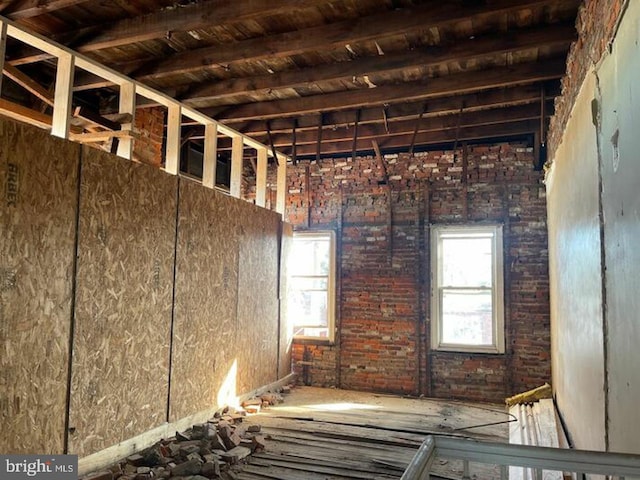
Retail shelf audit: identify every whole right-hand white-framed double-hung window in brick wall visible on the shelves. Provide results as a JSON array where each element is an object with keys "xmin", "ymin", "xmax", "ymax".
[{"xmin": 431, "ymin": 226, "xmax": 504, "ymax": 353}]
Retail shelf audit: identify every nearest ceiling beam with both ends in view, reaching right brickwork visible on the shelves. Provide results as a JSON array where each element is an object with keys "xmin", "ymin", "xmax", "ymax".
[{"xmin": 185, "ymin": 24, "xmax": 576, "ymax": 107}]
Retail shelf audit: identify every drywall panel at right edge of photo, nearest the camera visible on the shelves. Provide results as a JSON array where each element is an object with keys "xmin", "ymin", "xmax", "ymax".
[{"xmin": 598, "ymin": 2, "xmax": 640, "ymax": 454}]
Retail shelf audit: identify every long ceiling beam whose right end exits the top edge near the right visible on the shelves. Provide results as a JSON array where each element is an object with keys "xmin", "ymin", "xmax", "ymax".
[{"xmin": 131, "ymin": 0, "xmax": 564, "ymax": 79}]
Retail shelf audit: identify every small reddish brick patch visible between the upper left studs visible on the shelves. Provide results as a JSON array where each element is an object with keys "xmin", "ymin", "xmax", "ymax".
[{"xmin": 133, "ymin": 107, "xmax": 166, "ymax": 167}]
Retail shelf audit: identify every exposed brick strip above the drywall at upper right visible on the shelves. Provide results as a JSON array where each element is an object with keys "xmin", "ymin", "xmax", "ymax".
[{"xmin": 548, "ymin": 0, "xmax": 625, "ymax": 160}]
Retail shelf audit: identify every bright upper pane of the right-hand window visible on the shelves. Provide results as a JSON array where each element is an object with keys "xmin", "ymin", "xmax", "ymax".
[{"xmin": 441, "ymin": 237, "xmax": 492, "ymax": 287}]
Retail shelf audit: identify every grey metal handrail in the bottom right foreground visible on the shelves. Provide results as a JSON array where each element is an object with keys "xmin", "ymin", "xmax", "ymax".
[{"xmin": 402, "ymin": 435, "xmax": 640, "ymax": 480}]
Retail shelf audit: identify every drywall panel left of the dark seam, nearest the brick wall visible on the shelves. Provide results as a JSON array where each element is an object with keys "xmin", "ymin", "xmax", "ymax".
[{"xmin": 547, "ymin": 75, "xmax": 605, "ymax": 450}]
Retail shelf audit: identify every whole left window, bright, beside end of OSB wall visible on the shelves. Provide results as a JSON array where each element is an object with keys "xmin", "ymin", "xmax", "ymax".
[{"xmin": 287, "ymin": 232, "xmax": 335, "ymax": 341}]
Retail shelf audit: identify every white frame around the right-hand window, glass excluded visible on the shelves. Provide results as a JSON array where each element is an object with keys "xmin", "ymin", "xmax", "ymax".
[{"xmin": 430, "ymin": 224, "xmax": 505, "ymax": 354}]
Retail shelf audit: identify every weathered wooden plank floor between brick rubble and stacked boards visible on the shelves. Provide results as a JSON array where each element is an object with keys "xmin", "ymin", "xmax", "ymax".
[{"xmin": 236, "ymin": 387, "xmax": 510, "ymax": 480}]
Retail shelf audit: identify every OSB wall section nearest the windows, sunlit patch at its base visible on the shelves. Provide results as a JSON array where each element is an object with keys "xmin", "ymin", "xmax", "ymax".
[{"xmin": 171, "ymin": 181, "xmax": 286, "ymax": 420}]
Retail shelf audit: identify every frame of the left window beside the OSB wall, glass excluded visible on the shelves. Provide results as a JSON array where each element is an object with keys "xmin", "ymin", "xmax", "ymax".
[{"xmin": 287, "ymin": 230, "xmax": 336, "ymax": 344}]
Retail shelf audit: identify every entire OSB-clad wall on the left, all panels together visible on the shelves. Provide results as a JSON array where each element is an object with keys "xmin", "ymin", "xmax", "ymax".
[{"xmin": 0, "ymin": 120, "xmax": 288, "ymax": 457}]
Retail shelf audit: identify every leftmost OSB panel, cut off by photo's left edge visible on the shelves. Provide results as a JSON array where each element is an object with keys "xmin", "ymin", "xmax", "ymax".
[{"xmin": 0, "ymin": 120, "xmax": 80, "ymax": 454}]
